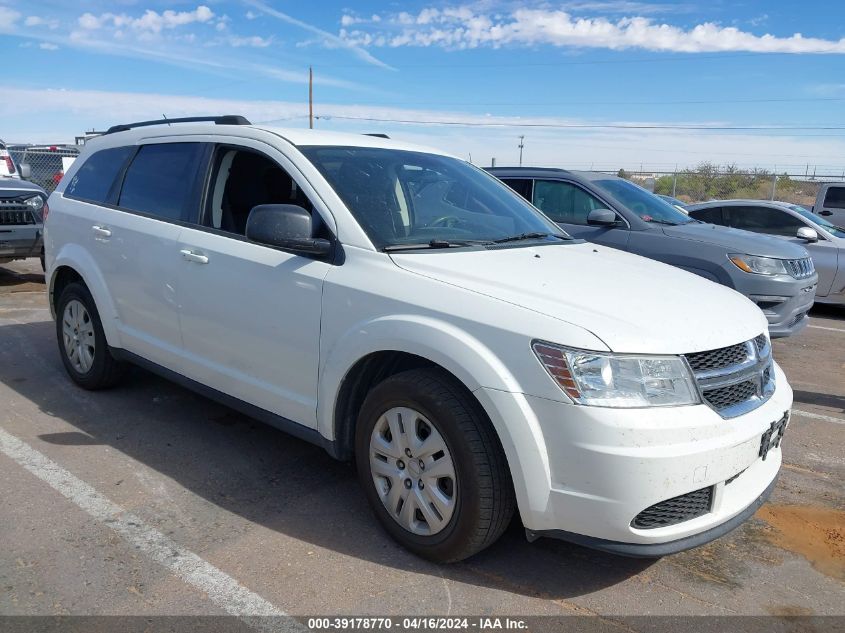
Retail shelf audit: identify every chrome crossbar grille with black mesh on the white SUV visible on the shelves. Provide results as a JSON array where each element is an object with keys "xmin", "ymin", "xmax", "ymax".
[{"xmin": 685, "ymin": 334, "xmax": 775, "ymax": 418}]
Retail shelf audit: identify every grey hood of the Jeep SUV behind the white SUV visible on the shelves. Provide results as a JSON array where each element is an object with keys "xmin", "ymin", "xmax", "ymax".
[{"xmin": 661, "ymin": 222, "xmax": 809, "ymax": 259}]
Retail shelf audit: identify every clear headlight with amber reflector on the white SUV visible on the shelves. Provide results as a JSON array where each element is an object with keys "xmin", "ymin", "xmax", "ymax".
[{"xmin": 531, "ymin": 341, "xmax": 700, "ymax": 409}]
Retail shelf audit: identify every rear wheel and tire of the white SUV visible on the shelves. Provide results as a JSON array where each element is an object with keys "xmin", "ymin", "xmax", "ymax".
[{"xmin": 56, "ymin": 282, "xmax": 126, "ymax": 390}]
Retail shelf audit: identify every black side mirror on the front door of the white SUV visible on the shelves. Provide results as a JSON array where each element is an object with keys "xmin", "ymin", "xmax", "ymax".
[{"xmin": 246, "ymin": 204, "xmax": 332, "ymax": 257}]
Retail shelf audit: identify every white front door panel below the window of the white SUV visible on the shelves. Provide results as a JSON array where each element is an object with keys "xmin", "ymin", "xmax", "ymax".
[{"xmin": 174, "ymin": 228, "xmax": 330, "ymax": 428}]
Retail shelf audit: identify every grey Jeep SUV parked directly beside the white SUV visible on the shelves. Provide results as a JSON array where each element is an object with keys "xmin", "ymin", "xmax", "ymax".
[{"xmin": 488, "ymin": 167, "xmax": 818, "ymax": 338}]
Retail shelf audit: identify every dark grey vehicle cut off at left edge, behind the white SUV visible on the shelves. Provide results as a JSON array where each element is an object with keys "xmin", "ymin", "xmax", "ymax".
[{"xmin": 0, "ymin": 177, "xmax": 49, "ymax": 267}]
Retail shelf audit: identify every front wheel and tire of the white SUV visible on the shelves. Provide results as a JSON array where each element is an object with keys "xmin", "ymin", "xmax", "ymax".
[{"xmin": 355, "ymin": 368, "xmax": 516, "ymax": 563}]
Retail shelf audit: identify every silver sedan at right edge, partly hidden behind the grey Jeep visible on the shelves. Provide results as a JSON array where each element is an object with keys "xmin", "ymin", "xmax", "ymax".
[{"xmin": 689, "ymin": 200, "xmax": 845, "ymax": 304}]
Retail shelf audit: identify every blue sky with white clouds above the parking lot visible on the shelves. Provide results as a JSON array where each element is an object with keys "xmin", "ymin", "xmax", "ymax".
[{"xmin": 0, "ymin": 0, "xmax": 845, "ymax": 174}]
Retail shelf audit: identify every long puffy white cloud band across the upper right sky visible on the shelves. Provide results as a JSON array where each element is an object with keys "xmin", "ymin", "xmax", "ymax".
[{"xmin": 340, "ymin": 3, "xmax": 845, "ymax": 54}]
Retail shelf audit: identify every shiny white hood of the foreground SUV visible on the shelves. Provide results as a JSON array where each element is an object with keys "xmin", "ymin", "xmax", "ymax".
[{"xmin": 391, "ymin": 243, "xmax": 767, "ymax": 354}]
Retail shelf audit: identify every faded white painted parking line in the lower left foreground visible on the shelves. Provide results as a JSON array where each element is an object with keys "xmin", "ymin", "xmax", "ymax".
[{"xmin": 0, "ymin": 428, "xmax": 298, "ymax": 630}]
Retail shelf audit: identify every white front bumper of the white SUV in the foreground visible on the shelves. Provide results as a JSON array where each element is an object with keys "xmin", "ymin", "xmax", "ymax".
[{"xmin": 480, "ymin": 365, "xmax": 792, "ymax": 555}]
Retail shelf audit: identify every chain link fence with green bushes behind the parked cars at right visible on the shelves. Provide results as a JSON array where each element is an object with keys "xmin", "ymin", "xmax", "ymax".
[{"xmin": 615, "ymin": 163, "xmax": 845, "ymax": 206}]
